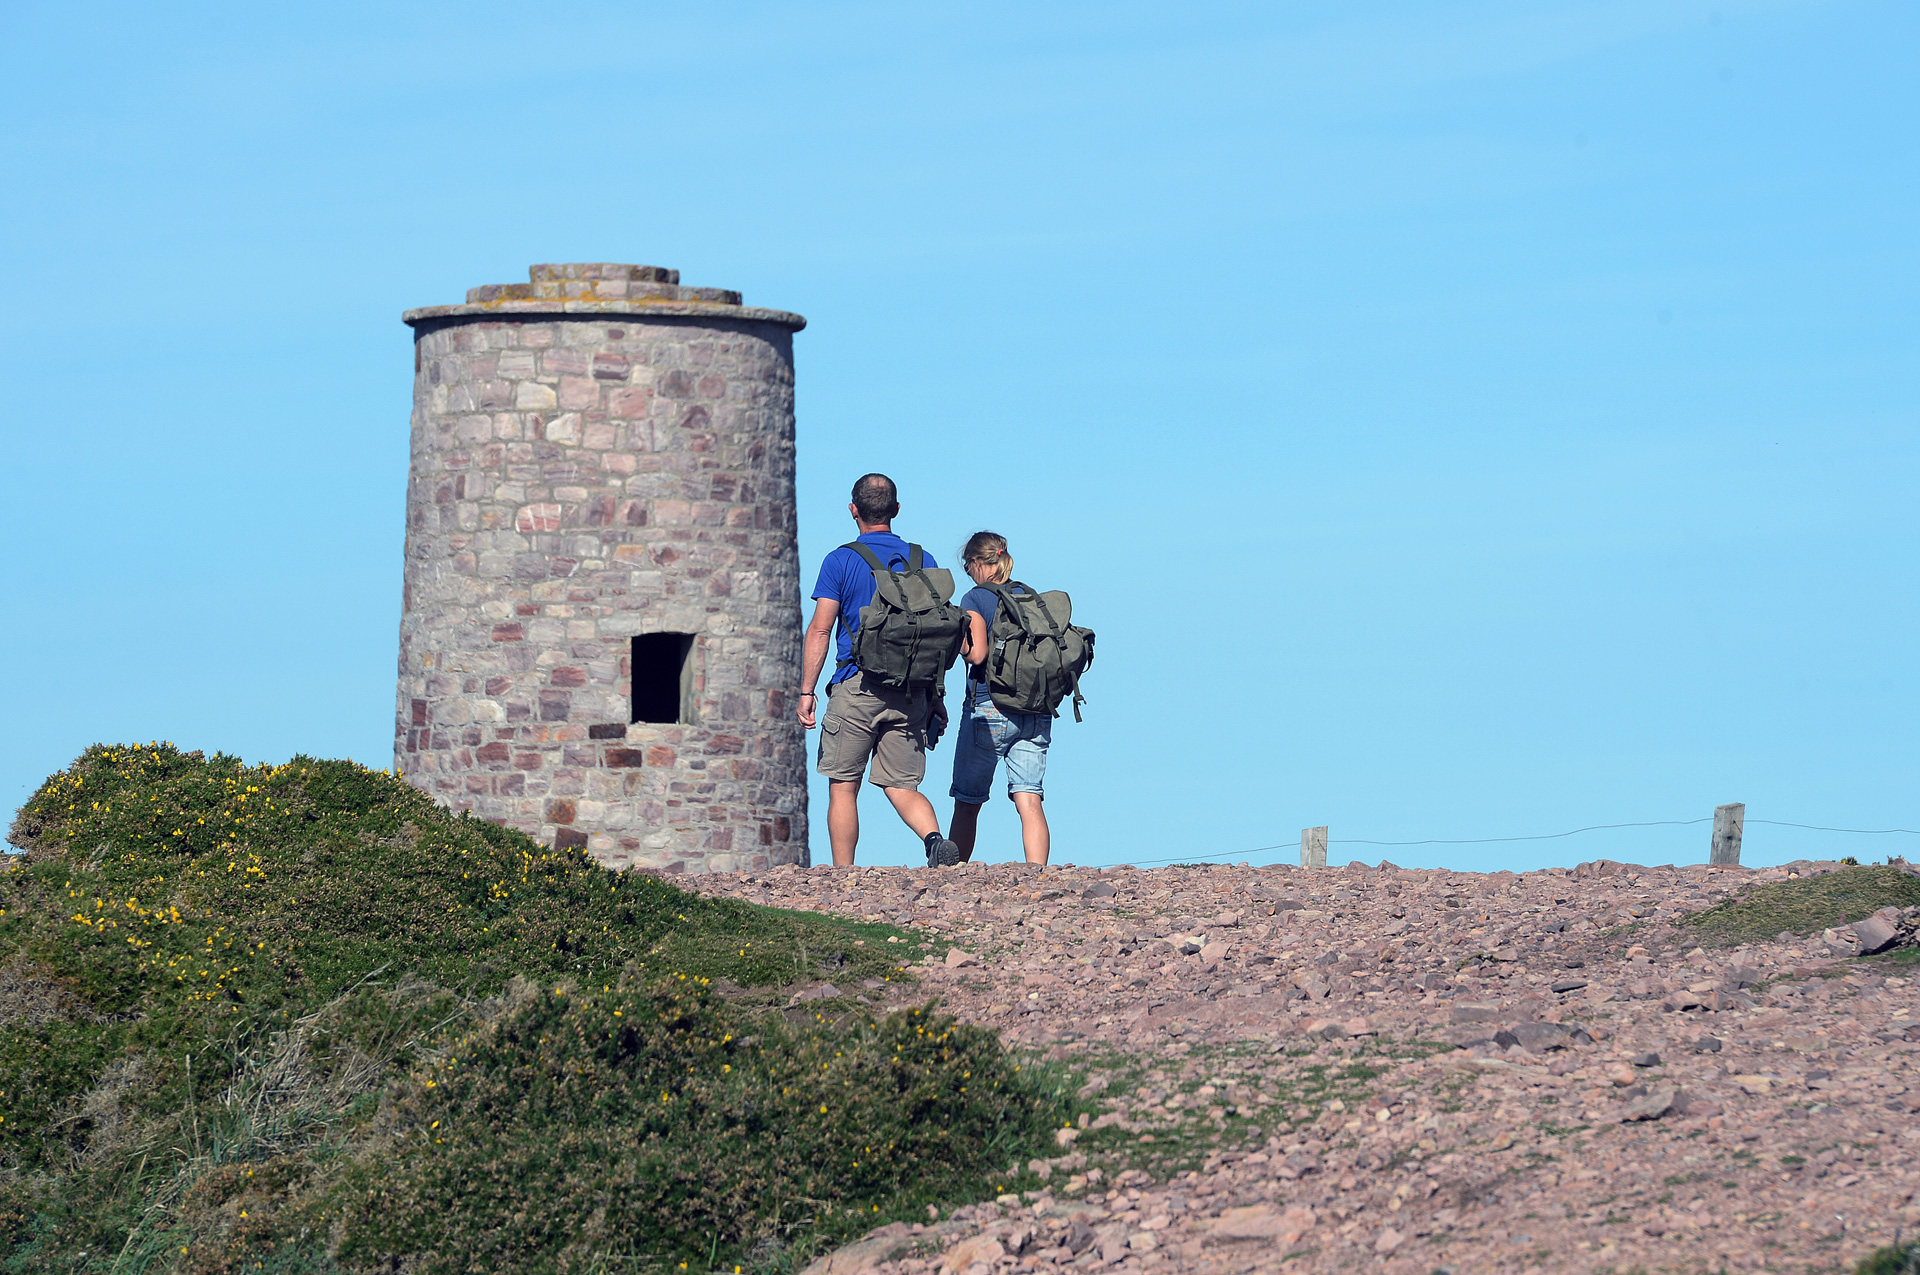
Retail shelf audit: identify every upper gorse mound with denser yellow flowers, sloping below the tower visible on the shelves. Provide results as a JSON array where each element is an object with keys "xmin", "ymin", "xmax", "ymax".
[{"xmin": 0, "ymin": 745, "xmax": 891, "ymax": 1167}]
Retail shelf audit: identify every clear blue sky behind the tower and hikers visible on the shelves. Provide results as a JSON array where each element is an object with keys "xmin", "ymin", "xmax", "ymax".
[{"xmin": 0, "ymin": 0, "xmax": 1920, "ymax": 868}]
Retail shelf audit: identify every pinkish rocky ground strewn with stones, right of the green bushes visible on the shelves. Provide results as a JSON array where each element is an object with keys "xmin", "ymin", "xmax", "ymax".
[{"xmin": 687, "ymin": 862, "xmax": 1920, "ymax": 1275}]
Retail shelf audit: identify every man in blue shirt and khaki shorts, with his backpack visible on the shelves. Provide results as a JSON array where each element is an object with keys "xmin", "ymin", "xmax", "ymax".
[{"xmin": 799, "ymin": 474, "xmax": 964, "ymax": 868}]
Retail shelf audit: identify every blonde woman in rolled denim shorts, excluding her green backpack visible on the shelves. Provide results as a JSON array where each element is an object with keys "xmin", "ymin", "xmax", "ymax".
[{"xmin": 947, "ymin": 532, "xmax": 1054, "ymax": 864}]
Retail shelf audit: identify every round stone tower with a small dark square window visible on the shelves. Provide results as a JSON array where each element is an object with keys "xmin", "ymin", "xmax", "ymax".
[{"xmin": 394, "ymin": 263, "xmax": 806, "ymax": 872}]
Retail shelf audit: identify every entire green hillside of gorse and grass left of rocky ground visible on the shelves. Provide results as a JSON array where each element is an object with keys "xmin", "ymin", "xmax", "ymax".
[{"xmin": 0, "ymin": 745, "xmax": 1068, "ymax": 1273}]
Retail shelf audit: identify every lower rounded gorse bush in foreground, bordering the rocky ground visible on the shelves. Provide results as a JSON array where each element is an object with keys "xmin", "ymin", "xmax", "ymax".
[{"xmin": 340, "ymin": 981, "xmax": 1052, "ymax": 1271}]
